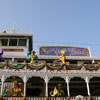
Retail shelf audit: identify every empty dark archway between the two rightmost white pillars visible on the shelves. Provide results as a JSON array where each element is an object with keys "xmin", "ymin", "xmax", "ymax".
[{"xmin": 69, "ymin": 77, "xmax": 88, "ymax": 96}]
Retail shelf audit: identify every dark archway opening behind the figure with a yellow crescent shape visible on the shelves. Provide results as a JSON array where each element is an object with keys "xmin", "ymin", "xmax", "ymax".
[{"xmin": 48, "ymin": 77, "xmax": 67, "ymax": 97}]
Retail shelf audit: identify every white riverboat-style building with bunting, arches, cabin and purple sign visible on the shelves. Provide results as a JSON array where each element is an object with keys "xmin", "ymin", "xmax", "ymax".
[{"xmin": 0, "ymin": 27, "xmax": 100, "ymax": 100}]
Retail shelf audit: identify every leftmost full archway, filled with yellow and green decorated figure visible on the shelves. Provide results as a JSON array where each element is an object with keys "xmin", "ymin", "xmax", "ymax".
[{"xmin": 3, "ymin": 76, "xmax": 24, "ymax": 97}]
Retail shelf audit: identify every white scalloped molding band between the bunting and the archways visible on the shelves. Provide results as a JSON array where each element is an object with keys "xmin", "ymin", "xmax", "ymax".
[{"xmin": 0, "ymin": 69, "xmax": 100, "ymax": 82}]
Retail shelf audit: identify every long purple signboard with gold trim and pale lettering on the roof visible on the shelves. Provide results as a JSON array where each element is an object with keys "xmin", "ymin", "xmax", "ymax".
[{"xmin": 39, "ymin": 46, "xmax": 90, "ymax": 56}]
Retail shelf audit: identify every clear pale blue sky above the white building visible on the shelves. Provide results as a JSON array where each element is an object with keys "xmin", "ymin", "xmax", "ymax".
[{"xmin": 0, "ymin": 0, "xmax": 100, "ymax": 57}]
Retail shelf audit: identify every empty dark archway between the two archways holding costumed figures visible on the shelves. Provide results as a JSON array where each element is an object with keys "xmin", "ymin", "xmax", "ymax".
[{"xmin": 26, "ymin": 77, "xmax": 45, "ymax": 97}]
